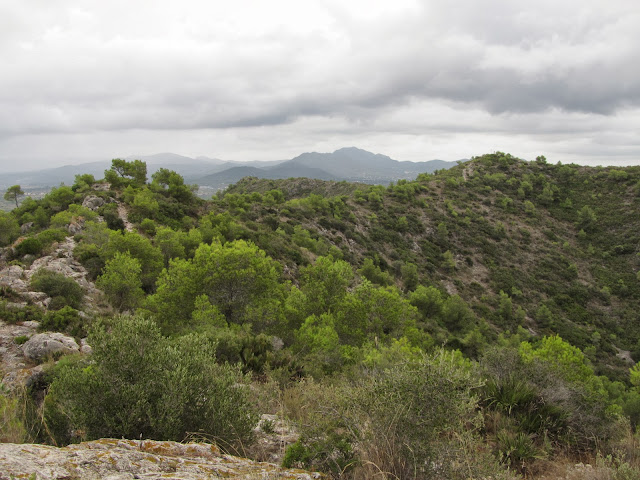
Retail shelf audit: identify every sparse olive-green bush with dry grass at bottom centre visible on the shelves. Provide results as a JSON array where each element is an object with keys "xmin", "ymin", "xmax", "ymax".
[{"xmin": 286, "ymin": 351, "xmax": 510, "ymax": 479}]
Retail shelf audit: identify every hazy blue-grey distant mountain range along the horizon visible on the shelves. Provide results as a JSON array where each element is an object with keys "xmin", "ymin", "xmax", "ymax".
[{"xmin": 0, "ymin": 147, "xmax": 458, "ymax": 190}]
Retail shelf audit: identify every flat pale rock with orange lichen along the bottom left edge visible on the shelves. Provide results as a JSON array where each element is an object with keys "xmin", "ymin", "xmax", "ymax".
[{"xmin": 0, "ymin": 439, "xmax": 321, "ymax": 480}]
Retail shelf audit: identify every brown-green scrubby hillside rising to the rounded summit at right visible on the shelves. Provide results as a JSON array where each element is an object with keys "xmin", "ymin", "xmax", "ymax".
[{"xmin": 220, "ymin": 155, "xmax": 640, "ymax": 376}]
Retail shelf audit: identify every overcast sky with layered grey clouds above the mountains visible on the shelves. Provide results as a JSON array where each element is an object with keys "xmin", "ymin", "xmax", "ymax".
[{"xmin": 0, "ymin": 0, "xmax": 640, "ymax": 171}]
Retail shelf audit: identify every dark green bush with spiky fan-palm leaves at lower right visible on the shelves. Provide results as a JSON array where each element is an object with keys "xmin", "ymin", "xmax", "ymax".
[{"xmin": 481, "ymin": 342, "xmax": 616, "ymax": 456}]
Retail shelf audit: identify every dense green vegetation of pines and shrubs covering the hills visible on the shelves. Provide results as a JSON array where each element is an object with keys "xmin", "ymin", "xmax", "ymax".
[{"xmin": 0, "ymin": 152, "xmax": 640, "ymax": 478}]
